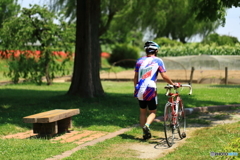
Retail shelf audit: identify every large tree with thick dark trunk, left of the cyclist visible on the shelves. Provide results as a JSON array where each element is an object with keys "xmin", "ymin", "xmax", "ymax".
[{"xmin": 52, "ymin": 0, "xmax": 131, "ymax": 97}]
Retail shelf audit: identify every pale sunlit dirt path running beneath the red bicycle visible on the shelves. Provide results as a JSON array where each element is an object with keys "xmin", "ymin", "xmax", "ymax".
[{"xmin": 125, "ymin": 110, "xmax": 240, "ymax": 159}]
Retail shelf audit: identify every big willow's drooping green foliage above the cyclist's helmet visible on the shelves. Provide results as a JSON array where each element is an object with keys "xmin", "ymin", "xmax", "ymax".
[{"xmin": 101, "ymin": 0, "xmax": 220, "ymax": 45}]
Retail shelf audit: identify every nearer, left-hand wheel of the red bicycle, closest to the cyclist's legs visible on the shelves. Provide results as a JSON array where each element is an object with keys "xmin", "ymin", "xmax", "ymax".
[{"xmin": 164, "ymin": 105, "xmax": 175, "ymax": 147}]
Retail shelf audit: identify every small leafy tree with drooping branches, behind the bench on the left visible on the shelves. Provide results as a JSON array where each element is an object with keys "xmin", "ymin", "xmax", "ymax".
[{"xmin": 0, "ymin": 5, "xmax": 75, "ymax": 84}]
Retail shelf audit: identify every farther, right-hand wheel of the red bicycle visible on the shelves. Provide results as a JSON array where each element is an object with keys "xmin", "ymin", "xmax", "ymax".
[{"xmin": 178, "ymin": 101, "xmax": 187, "ymax": 139}]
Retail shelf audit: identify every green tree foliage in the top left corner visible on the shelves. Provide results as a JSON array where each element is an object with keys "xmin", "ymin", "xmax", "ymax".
[{"xmin": 0, "ymin": 0, "xmax": 20, "ymax": 28}]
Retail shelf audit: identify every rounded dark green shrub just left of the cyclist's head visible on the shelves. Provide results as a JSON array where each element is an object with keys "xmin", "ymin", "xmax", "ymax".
[{"xmin": 108, "ymin": 44, "xmax": 139, "ymax": 68}]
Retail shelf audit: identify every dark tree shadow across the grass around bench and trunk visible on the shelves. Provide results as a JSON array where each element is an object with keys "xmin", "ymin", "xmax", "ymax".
[{"xmin": 0, "ymin": 84, "xmax": 237, "ymax": 135}]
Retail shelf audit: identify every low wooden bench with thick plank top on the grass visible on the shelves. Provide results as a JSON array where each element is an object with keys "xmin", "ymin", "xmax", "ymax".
[{"xmin": 23, "ymin": 109, "xmax": 80, "ymax": 135}]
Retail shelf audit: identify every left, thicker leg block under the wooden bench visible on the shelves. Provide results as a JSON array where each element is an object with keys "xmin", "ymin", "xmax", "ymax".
[{"xmin": 33, "ymin": 122, "xmax": 58, "ymax": 135}]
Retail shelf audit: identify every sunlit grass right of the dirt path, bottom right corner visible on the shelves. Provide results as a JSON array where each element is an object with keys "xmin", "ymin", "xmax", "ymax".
[{"xmin": 158, "ymin": 122, "xmax": 240, "ymax": 160}]
